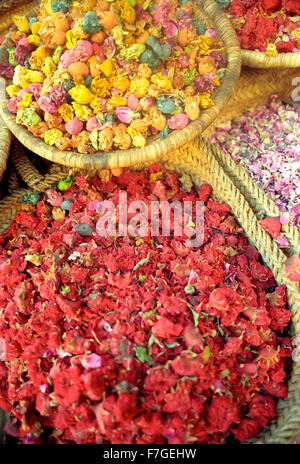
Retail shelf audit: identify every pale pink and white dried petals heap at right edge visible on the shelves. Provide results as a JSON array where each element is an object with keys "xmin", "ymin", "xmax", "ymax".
[{"xmin": 212, "ymin": 95, "xmax": 300, "ymax": 239}]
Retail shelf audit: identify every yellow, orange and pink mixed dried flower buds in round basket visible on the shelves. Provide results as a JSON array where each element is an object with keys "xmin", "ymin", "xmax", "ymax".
[{"xmin": 0, "ymin": 0, "xmax": 227, "ymax": 153}]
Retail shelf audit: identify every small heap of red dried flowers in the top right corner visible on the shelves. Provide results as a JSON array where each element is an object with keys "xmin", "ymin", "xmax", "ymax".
[{"xmin": 217, "ymin": 0, "xmax": 300, "ymax": 56}]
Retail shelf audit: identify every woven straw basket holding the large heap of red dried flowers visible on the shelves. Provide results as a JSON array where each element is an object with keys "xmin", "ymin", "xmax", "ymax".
[{"xmin": 0, "ymin": 138, "xmax": 300, "ymax": 443}]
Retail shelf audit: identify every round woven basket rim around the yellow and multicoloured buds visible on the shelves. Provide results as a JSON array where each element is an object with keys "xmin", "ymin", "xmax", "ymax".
[{"xmin": 0, "ymin": 0, "xmax": 241, "ymax": 169}]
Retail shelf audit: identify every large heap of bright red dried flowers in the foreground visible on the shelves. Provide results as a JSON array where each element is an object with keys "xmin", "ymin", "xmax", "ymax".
[{"xmin": 0, "ymin": 164, "xmax": 292, "ymax": 444}]
